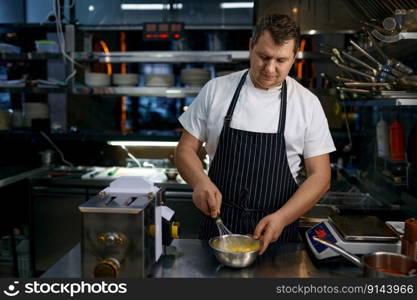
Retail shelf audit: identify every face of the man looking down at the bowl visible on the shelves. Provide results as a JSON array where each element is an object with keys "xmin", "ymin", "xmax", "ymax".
[{"xmin": 249, "ymin": 31, "xmax": 295, "ymax": 89}]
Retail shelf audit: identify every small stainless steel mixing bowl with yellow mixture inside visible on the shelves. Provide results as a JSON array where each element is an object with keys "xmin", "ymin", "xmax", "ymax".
[{"xmin": 209, "ymin": 234, "xmax": 260, "ymax": 268}]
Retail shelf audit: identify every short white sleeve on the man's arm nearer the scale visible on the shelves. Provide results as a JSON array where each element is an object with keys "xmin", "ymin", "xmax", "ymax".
[{"xmin": 303, "ymin": 98, "xmax": 336, "ymax": 158}]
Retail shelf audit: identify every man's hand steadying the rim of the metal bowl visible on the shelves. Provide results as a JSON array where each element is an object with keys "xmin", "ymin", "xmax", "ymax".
[{"xmin": 253, "ymin": 213, "xmax": 285, "ymax": 255}]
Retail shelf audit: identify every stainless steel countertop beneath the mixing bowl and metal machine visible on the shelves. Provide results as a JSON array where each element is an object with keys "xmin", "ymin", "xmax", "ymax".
[{"xmin": 42, "ymin": 239, "xmax": 362, "ymax": 278}]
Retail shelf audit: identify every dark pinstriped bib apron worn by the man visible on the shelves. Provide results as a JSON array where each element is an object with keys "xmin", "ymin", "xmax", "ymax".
[{"xmin": 200, "ymin": 71, "xmax": 298, "ymax": 243}]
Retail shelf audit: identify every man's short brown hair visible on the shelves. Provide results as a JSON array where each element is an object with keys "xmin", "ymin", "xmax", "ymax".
[{"xmin": 252, "ymin": 14, "xmax": 300, "ymax": 53}]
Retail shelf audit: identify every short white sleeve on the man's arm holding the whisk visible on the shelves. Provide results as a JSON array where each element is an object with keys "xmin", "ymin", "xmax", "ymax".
[{"xmin": 178, "ymin": 82, "xmax": 210, "ymax": 142}]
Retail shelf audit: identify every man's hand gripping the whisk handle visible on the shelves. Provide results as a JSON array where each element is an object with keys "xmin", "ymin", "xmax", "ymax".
[{"xmin": 193, "ymin": 181, "xmax": 222, "ymax": 218}]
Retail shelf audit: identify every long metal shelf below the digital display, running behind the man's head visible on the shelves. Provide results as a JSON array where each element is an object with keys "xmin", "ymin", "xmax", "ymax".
[{"xmin": 74, "ymin": 50, "xmax": 324, "ymax": 63}]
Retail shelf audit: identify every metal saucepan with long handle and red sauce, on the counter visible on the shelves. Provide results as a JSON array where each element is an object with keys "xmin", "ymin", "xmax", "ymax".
[{"xmin": 313, "ymin": 237, "xmax": 417, "ymax": 278}]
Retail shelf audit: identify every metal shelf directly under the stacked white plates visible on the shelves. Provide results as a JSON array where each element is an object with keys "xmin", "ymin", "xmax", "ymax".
[{"xmin": 73, "ymin": 86, "xmax": 201, "ymax": 98}]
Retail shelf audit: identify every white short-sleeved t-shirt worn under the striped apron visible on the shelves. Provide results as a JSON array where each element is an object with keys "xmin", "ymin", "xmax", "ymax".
[{"xmin": 179, "ymin": 70, "xmax": 336, "ymax": 182}]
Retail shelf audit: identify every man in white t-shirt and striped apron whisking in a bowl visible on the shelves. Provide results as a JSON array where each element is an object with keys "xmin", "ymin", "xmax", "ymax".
[{"xmin": 175, "ymin": 14, "xmax": 335, "ymax": 254}]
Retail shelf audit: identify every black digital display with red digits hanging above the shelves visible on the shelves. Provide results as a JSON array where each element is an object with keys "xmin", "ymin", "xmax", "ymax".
[{"xmin": 143, "ymin": 22, "xmax": 184, "ymax": 41}]
